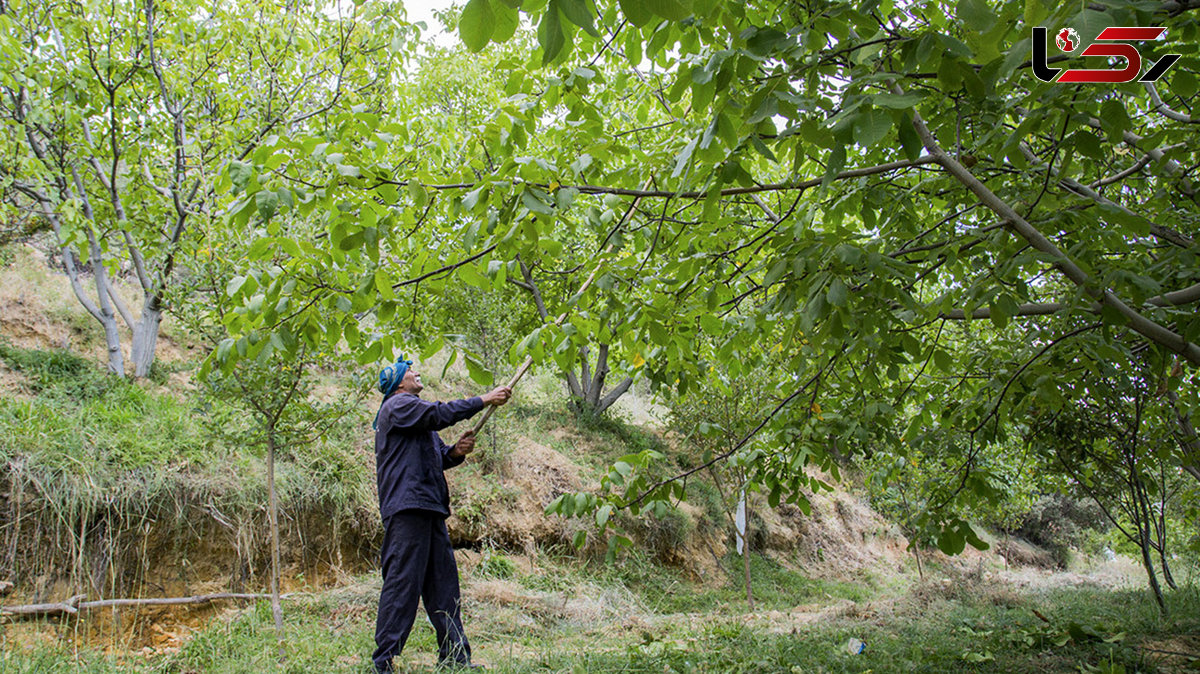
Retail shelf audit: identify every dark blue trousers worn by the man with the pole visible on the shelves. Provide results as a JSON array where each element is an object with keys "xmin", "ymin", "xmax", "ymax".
[{"xmin": 372, "ymin": 511, "xmax": 470, "ymax": 672}]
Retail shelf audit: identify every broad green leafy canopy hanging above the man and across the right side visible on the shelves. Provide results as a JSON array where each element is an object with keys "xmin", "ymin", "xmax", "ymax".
[{"xmin": 6, "ymin": 0, "xmax": 1200, "ymax": 552}]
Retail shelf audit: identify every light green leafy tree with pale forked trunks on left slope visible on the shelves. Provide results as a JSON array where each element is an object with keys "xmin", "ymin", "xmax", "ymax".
[{"xmin": 0, "ymin": 0, "xmax": 420, "ymax": 377}]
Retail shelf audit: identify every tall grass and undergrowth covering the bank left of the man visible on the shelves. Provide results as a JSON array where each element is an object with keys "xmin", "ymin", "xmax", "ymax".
[{"xmin": 0, "ymin": 343, "xmax": 377, "ymax": 597}]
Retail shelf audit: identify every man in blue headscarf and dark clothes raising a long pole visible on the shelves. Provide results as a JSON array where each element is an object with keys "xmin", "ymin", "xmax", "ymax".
[{"xmin": 372, "ymin": 357, "xmax": 512, "ymax": 672}]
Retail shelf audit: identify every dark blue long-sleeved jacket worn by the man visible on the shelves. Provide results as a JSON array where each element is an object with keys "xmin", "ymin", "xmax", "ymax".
[{"xmin": 376, "ymin": 391, "xmax": 484, "ymax": 519}]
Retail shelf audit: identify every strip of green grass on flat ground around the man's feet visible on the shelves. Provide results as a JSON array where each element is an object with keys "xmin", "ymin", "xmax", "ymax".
[{"xmin": 0, "ymin": 567, "xmax": 1200, "ymax": 674}]
